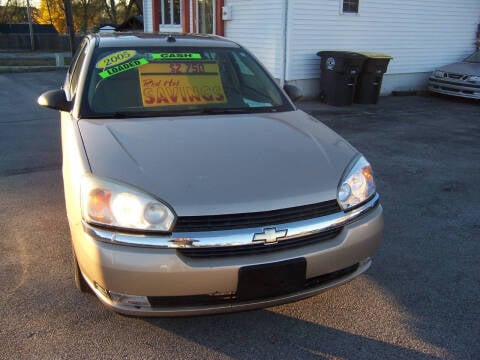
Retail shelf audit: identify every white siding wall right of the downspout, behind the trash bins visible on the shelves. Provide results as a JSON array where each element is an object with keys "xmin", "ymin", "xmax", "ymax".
[{"xmin": 286, "ymin": 0, "xmax": 480, "ymax": 80}]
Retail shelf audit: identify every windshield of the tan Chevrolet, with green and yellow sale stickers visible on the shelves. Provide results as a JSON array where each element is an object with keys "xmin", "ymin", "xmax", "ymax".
[{"xmin": 80, "ymin": 47, "xmax": 292, "ymax": 118}]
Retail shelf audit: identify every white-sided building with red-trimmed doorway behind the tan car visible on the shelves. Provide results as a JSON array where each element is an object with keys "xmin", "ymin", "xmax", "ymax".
[{"xmin": 144, "ymin": 0, "xmax": 480, "ymax": 97}]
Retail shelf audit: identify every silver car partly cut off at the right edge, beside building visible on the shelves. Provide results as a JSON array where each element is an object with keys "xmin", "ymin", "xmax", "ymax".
[{"xmin": 428, "ymin": 50, "xmax": 480, "ymax": 99}]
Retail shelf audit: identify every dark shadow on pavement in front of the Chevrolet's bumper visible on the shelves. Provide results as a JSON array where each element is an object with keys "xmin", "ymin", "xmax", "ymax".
[{"xmin": 145, "ymin": 310, "xmax": 437, "ymax": 359}]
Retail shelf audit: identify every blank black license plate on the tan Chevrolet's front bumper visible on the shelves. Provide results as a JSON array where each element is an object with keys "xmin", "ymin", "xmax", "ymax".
[{"xmin": 237, "ymin": 258, "xmax": 307, "ymax": 301}]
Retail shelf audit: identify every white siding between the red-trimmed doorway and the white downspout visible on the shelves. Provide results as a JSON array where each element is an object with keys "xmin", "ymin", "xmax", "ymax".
[{"xmin": 225, "ymin": 0, "xmax": 284, "ymax": 78}]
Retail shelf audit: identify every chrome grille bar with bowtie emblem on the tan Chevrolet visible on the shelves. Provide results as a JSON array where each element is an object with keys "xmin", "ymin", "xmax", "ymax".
[{"xmin": 82, "ymin": 194, "xmax": 380, "ymax": 250}]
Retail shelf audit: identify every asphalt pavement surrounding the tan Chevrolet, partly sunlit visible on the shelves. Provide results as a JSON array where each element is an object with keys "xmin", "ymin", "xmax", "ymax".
[{"xmin": 0, "ymin": 71, "xmax": 480, "ymax": 359}]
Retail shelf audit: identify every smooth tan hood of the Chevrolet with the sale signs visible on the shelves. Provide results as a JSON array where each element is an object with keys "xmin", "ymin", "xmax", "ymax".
[{"xmin": 78, "ymin": 110, "xmax": 357, "ymax": 216}]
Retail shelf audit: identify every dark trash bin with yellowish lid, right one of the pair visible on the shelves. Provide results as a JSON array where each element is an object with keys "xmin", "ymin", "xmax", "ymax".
[{"xmin": 354, "ymin": 52, "xmax": 392, "ymax": 104}]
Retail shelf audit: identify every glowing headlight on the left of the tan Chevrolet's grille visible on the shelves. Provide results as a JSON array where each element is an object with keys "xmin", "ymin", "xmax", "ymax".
[{"xmin": 81, "ymin": 175, "xmax": 175, "ymax": 232}]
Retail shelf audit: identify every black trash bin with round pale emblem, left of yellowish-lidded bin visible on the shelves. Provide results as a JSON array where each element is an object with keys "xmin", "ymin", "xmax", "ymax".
[{"xmin": 317, "ymin": 51, "xmax": 366, "ymax": 106}]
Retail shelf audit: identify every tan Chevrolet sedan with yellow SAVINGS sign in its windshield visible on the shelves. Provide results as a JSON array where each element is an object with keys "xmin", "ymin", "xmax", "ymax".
[{"xmin": 38, "ymin": 33, "xmax": 383, "ymax": 315}]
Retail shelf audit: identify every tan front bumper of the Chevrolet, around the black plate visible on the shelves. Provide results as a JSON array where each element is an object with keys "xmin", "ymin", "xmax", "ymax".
[{"xmin": 73, "ymin": 198, "xmax": 383, "ymax": 316}]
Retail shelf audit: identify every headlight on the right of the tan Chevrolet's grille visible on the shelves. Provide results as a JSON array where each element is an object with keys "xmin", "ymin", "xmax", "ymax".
[{"xmin": 337, "ymin": 155, "xmax": 376, "ymax": 210}]
